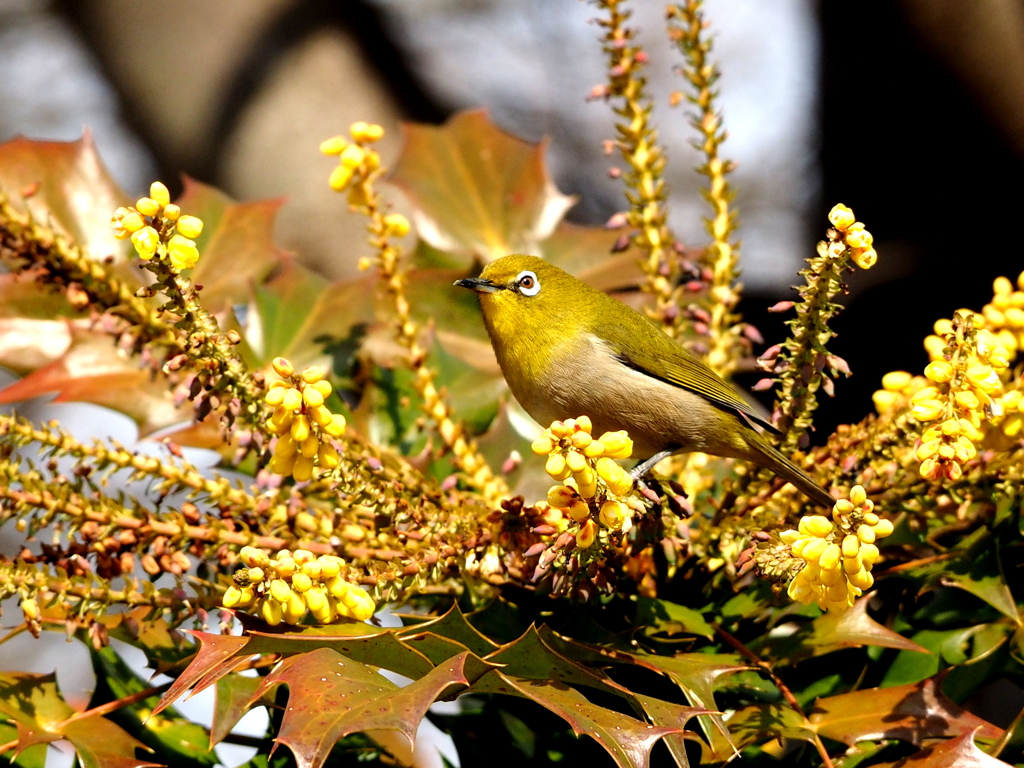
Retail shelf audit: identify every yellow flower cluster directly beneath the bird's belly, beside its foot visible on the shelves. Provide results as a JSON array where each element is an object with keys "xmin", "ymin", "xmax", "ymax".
[{"xmin": 531, "ymin": 416, "xmax": 643, "ymax": 549}]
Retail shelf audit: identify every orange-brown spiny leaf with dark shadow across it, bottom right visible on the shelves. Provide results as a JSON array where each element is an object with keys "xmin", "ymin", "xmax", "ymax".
[{"xmin": 809, "ymin": 676, "xmax": 1002, "ymax": 746}]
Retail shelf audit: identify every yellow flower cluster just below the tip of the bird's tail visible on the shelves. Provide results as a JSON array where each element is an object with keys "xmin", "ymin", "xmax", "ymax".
[{"xmin": 779, "ymin": 485, "xmax": 893, "ymax": 610}]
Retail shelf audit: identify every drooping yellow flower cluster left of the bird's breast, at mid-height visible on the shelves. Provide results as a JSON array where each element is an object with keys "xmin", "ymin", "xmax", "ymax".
[{"xmin": 263, "ymin": 357, "xmax": 345, "ymax": 482}]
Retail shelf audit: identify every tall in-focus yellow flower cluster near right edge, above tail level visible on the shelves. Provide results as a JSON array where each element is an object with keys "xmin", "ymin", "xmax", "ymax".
[{"xmin": 910, "ymin": 312, "xmax": 1010, "ymax": 480}]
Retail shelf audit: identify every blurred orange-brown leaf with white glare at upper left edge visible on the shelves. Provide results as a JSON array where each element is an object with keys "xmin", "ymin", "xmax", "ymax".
[{"xmin": 0, "ymin": 133, "xmax": 131, "ymax": 260}]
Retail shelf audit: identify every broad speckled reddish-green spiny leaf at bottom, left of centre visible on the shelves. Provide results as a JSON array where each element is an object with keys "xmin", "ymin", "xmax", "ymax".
[{"xmin": 257, "ymin": 648, "xmax": 469, "ymax": 768}]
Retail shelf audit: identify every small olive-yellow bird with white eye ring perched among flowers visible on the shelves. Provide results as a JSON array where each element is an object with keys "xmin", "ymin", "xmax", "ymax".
[{"xmin": 455, "ymin": 254, "xmax": 835, "ymax": 508}]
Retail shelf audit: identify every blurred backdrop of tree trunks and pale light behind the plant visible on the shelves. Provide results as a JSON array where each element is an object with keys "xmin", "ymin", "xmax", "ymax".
[{"xmin": 6, "ymin": 0, "xmax": 1024, "ymax": 434}]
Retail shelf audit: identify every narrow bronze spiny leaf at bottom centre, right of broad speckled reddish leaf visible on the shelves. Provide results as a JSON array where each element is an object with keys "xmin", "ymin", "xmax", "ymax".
[{"xmin": 490, "ymin": 671, "xmax": 683, "ymax": 768}]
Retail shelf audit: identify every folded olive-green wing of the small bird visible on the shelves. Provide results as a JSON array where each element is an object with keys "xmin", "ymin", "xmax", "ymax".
[{"xmin": 594, "ymin": 311, "xmax": 778, "ymax": 434}]
